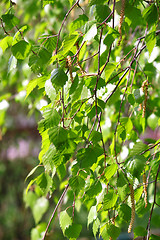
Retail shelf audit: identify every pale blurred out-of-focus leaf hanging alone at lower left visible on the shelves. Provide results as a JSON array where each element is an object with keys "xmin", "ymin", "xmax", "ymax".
[{"xmin": 33, "ymin": 197, "xmax": 49, "ymax": 224}]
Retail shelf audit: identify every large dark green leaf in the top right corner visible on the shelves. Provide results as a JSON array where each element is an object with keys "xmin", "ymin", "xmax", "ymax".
[{"xmin": 143, "ymin": 4, "xmax": 158, "ymax": 26}]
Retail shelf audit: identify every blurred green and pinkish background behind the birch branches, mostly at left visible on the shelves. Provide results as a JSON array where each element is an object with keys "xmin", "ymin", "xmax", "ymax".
[{"xmin": 0, "ymin": 0, "xmax": 160, "ymax": 240}]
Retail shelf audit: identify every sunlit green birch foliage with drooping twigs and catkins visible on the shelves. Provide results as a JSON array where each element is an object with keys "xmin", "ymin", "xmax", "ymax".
[{"xmin": 0, "ymin": 0, "xmax": 160, "ymax": 240}]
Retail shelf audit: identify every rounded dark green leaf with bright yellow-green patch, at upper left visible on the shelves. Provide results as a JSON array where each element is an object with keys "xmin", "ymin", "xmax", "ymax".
[{"xmin": 11, "ymin": 40, "xmax": 31, "ymax": 60}]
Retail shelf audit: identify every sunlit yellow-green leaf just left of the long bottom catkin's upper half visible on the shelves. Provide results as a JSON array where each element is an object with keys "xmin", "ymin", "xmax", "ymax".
[{"xmin": 103, "ymin": 192, "xmax": 118, "ymax": 210}]
